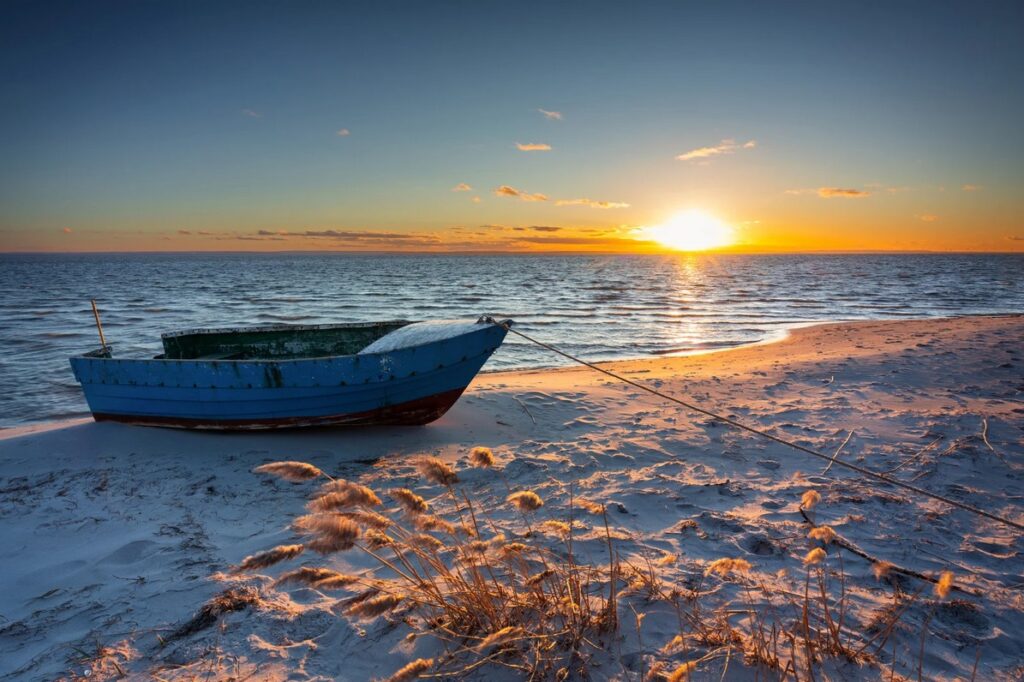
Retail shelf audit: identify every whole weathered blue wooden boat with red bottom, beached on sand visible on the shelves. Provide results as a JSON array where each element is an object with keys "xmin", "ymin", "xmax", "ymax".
[{"xmin": 71, "ymin": 317, "xmax": 511, "ymax": 429}]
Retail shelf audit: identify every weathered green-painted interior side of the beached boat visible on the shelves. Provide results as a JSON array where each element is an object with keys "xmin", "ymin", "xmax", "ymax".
[{"xmin": 164, "ymin": 321, "xmax": 409, "ymax": 359}]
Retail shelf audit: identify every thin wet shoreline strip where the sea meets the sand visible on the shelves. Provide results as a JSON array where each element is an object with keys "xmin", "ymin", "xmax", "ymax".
[{"xmin": 0, "ymin": 312, "xmax": 1024, "ymax": 441}]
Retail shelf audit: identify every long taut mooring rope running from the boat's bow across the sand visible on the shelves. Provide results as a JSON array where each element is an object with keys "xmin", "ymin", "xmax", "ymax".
[{"xmin": 485, "ymin": 317, "xmax": 1024, "ymax": 530}]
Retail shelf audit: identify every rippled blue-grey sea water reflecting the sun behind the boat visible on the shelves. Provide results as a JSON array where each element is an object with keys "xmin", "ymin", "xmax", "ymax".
[{"xmin": 0, "ymin": 254, "xmax": 1024, "ymax": 427}]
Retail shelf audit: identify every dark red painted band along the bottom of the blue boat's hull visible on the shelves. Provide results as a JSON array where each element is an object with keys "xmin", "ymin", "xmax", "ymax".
[{"xmin": 92, "ymin": 387, "xmax": 466, "ymax": 431}]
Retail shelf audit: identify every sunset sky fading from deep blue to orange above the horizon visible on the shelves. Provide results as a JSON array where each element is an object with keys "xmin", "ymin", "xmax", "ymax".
[{"xmin": 0, "ymin": 0, "xmax": 1024, "ymax": 252}]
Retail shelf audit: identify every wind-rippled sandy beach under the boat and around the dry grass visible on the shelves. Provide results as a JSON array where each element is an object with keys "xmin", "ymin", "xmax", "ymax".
[{"xmin": 0, "ymin": 315, "xmax": 1024, "ymax": 680}]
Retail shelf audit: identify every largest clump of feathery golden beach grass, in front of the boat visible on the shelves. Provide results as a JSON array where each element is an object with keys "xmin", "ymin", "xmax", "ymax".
[{"xmin": 247, "ymin": 449, "xmax": 621, "ymax": 680}]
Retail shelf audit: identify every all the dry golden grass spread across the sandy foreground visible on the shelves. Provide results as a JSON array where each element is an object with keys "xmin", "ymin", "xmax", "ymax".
[{"xmin": 239, "ymin": 449, "xmax": 953, "ymax": 680}]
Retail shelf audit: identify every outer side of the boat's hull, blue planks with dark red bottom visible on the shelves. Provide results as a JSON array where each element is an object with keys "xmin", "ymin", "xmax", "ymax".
[{"xmin": 71, "ymin": 323, "xmax": 506, "ymax": 430}]
